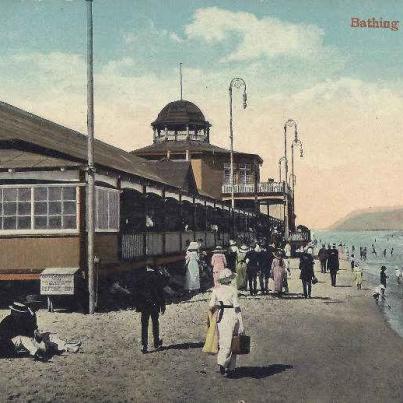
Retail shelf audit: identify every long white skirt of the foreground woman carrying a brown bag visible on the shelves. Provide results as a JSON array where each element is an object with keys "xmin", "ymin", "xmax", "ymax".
[{"xmin": 217, "ymin": 309, "xmax": 239, "ymax": 371}]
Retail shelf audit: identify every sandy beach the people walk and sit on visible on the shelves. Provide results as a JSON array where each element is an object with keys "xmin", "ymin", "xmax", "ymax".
[{"xmin": 0, "ymin": 261, "xmax": 403, "ymax": 402}]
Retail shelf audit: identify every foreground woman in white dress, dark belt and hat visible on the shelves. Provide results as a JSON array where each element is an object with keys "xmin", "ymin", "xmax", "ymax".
[{"xmin": 209, "ymin": 269, "xmax": 244, "ymax": 376}]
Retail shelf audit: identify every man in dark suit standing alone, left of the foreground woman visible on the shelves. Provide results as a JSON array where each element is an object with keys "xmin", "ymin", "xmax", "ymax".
[{"xmin": 136, "ymin": 258, "xmax": 165, "ymax": 354}]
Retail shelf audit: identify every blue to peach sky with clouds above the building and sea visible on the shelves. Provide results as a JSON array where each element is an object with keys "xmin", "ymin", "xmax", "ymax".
[{"xmin": 0, "ymin": 0, "xmax": 403, "ymax": 228}]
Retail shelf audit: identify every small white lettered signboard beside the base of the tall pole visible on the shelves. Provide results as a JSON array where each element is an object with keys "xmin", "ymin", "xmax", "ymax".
[{"xmin": 41, "ymin": 267, "xmax": 78, "ymax": 295}]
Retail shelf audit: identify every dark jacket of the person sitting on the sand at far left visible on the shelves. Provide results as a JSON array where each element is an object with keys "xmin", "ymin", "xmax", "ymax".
[{"xmin": 0, "ymin": 308, "xmax": 38, "ymax": 356}]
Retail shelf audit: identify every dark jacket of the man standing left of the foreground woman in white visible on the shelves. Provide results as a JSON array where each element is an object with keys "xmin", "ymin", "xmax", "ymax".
[{"xmin": 135, "ymin": 270, "xmax": 165, "ymax": 312}]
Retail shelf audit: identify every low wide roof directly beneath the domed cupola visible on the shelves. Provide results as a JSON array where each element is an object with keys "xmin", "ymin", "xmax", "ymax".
[{"xmin": 131, "ymin": 140, "xmax": 263, "ymax": 162}]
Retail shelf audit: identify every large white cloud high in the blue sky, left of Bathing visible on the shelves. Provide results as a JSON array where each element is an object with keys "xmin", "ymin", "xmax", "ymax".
[{"xmin": 185, "ymin": 7, "xmax": 324, "ymax": 61}]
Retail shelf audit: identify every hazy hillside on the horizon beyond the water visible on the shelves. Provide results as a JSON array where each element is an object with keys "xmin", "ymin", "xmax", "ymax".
[{"xmin": 329, "ymin": 207, "xmax": 403, "ymax": 231}]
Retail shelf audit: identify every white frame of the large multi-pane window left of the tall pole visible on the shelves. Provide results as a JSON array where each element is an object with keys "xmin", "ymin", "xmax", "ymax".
[{"xmin": 0, "ymin": 183, "xmax": 83, "ymax": 236}]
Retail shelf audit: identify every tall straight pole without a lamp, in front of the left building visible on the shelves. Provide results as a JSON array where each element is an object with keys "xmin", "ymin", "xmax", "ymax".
[{"xmin": 86, "ymin": 0, "xmax": 96, "ymax": 314}]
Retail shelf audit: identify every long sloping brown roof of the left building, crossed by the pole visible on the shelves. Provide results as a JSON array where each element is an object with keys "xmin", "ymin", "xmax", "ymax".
[{"xmin": 0, "ymin": 102, "xmax": 169, "ymax": 183}]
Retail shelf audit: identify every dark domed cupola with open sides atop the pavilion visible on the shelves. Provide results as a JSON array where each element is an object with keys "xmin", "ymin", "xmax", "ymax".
[{"xmin": 151, "ymin": 99, "xmax": 211, "ymax": 143}]
